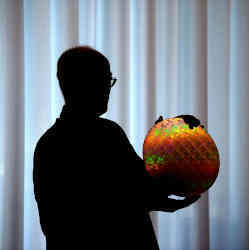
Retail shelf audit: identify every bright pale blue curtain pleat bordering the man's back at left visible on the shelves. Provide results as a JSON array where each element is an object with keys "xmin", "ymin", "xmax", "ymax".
[{"xmin": 24, "ymin": 0, "xmax": 51, "ymax": 250}]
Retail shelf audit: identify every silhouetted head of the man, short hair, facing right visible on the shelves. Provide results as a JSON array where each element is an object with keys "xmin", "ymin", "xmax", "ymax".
[{"xmin": 57, "ymin": 46, "xmax": 112, "ymax": 115}]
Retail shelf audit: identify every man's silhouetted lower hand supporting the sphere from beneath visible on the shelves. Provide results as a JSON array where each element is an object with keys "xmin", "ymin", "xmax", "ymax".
[{"xmin": 151, "ymin": 195, "xmax": 201, "ymax": 213}]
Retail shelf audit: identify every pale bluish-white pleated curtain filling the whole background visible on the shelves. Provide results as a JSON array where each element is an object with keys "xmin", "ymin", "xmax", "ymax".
[{"xmin": 0, "ymin": 0, "xmax": 249, "ymax": 250}]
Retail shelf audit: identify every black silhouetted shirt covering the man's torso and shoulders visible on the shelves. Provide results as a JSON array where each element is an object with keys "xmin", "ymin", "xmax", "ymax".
[{"xmin": 33, "ymin": 106, "xmax": 159, "ymax": 250}]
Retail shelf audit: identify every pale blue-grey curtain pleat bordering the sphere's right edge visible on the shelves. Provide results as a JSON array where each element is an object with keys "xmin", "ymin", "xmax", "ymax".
[{"xmin": 207, "ymin": 0, "xmax": 231, "ymax": 250}]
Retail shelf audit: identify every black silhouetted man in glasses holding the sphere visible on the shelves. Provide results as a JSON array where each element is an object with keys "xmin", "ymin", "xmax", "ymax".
[{"xmin": 33, "ymin": 46, "xmax": 199, "ymax": 250}]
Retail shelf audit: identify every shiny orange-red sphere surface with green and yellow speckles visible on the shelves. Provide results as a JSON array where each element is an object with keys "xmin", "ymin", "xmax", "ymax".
[{"xmin": 143, "ymin": 118, "xmax": 220, "ymax": 196}]
